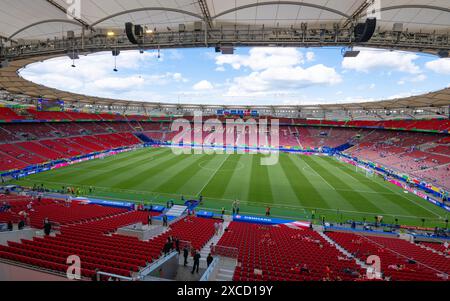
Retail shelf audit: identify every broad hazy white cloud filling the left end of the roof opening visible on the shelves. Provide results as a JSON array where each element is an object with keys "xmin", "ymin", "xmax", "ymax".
[{"xmin": 21, "ymin": 51, "xmax": 188, "ymax": 100}]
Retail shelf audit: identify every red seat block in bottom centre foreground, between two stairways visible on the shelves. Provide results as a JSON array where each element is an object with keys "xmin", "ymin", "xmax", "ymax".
[{"xmin": 217, "ymin": 222, "xmax": 363, "ymax": 281}]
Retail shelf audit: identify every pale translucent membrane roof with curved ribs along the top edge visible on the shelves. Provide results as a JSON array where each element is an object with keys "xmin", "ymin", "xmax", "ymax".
[{"xmin": 0, "ymin": 0, "xmax": 450, "ymax": 40}]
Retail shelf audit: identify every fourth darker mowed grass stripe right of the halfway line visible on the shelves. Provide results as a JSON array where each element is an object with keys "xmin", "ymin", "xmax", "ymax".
[{"xmin": 302, "ymin": 156, "xmax": 384, "ymax": 213}]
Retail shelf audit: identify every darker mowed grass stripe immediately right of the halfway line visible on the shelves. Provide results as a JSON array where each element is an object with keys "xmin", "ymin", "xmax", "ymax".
[{"xmin": 201, "ymin": 155, "xmax": 240, "ymax": 199}]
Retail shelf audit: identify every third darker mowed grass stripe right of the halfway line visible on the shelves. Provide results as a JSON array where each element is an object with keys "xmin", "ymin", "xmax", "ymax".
[{"xmin": 280, "ymin": 154, "xmax": 329, "ymax": 208}]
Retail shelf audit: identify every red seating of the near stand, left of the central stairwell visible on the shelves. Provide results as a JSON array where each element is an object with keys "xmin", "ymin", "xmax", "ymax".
[{"xmin": 0, "ymin": 196, "xmax": 215, "ymax": 277}]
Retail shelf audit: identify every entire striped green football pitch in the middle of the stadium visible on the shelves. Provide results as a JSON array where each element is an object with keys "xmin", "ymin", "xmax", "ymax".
[{"xmin": 9, "ymin": 148, "xmax": 447, "ymax": 227}]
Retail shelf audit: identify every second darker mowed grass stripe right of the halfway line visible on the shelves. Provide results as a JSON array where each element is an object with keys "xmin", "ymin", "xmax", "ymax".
[{"xmin": 248, "ymin": 155, "xmax": 273, "ymax": 204}]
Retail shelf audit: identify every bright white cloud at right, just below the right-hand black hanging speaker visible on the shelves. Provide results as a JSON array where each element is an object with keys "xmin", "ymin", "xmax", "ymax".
[{"xmin": 342, "ymin": 49, "xmax": 421, "ymax": 74}]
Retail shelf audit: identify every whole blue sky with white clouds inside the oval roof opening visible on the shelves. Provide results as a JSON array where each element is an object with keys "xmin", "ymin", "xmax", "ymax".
[{"xmin": 21, "ymin": 48, "xmax": 450, "ymax": 105}]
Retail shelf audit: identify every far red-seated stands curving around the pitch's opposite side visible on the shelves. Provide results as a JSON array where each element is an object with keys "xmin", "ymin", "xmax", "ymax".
[{"xmin": 0, "ymin": 116, "xmax": 450, "ymax": 189}]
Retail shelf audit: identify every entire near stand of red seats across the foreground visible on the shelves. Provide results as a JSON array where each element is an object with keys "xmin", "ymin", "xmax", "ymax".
[{"xmin": 0, "ymin": 195, "xmax": 450, "ymax": 281}]
